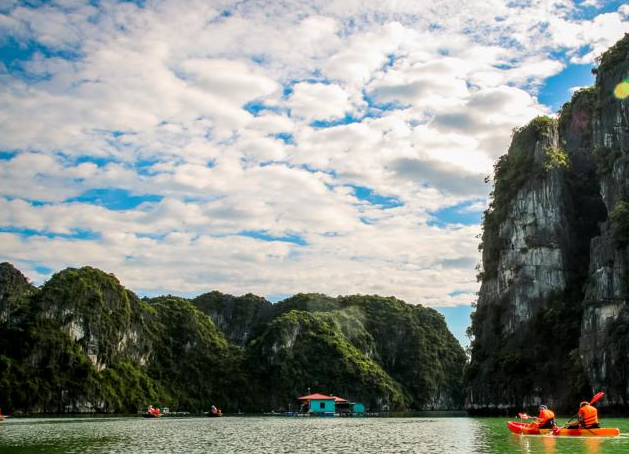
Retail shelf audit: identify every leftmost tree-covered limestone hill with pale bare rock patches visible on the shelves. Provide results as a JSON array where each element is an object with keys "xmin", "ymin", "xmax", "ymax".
[{"xmin": 0, "ymin": 267, "xmax": 241, "ymax": 413}]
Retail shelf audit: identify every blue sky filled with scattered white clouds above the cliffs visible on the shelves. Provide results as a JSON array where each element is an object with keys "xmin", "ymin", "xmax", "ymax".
[{"xmin": 0, "ymin": 0, "xmax": 629, "ymax": 343}]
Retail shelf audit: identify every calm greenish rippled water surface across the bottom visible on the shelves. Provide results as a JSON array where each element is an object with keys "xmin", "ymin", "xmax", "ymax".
[{"xmin": 0, "ymin": 417, "xmax": 629, "ymax": 454}]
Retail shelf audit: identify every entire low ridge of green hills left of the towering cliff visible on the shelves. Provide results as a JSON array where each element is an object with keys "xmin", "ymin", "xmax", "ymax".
[{"xmin": 0, "ymin": 263, "xmax": 466, "ymax": 413}]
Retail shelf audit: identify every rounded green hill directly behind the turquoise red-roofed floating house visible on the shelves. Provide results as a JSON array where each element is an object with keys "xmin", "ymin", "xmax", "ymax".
[{"xmin": 247, "ymin": 310, "xmax": 406, "ymax": 409}]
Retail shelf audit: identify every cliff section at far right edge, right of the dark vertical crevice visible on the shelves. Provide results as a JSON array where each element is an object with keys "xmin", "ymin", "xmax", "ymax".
[{"xmin": 580, "ymin": 36, "xmax": 629, "ymax": 409}]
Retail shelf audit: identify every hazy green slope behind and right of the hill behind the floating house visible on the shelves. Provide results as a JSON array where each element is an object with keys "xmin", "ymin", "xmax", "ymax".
[{"xmin": 260, "ymin": 294, "xmax": 466, "ymax": 409}]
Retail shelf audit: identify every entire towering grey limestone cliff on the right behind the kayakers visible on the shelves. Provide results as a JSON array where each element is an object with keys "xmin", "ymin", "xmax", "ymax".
[{"xmin": 466, "ymin": 36, "xmax": 629, "ymax": 413}]
